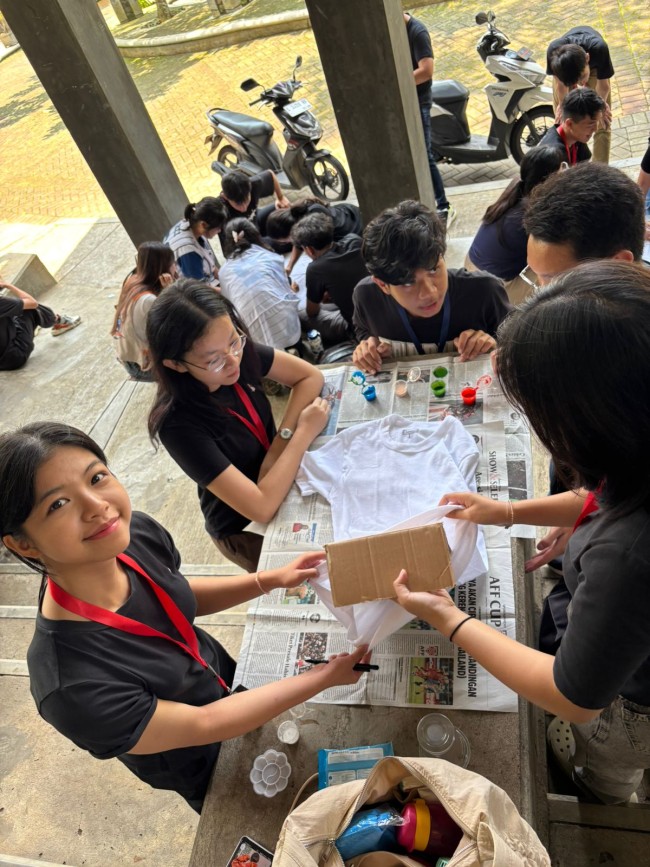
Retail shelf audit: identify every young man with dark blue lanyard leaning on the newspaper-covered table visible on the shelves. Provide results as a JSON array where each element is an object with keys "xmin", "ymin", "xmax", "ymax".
[{"xmin": 352, "ymin": 201, "xmax": 511, "ymax": 373}]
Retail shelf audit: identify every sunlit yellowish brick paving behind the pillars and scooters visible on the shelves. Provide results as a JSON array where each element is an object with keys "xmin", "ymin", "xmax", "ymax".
[{"xmin": 0, "ymin": 0, "xmax": 650, "ymax": 224}]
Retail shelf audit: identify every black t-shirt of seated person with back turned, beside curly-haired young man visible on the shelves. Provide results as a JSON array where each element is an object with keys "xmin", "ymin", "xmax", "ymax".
[{"xmin": 306, "ymin": 234, "xmax": 368, "ymax": 327}]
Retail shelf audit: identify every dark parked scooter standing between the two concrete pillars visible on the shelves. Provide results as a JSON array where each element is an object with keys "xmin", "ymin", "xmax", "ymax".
[{"xmin": 205, "ymin": 56, "xmax": 350, "ymax": 202}]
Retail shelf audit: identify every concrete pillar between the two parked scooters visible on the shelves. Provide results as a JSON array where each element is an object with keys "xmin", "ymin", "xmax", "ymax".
[{"xmin": 306, "ymin": 0, "xmax": 435, "ymax": 227}]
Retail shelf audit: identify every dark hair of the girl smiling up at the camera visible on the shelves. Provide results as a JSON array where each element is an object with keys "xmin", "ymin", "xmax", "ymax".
[{"xmin": 0, "ymin": 421, "xmax": 106, "ymax": 599}]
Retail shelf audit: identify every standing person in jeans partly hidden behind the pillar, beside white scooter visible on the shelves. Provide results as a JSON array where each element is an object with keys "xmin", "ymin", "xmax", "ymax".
[{"xmin": 404, "ymin": 12, "xmax": 456, "ymax": 220}]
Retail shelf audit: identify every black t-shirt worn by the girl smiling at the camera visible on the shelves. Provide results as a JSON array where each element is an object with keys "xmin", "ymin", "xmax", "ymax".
[{"xmin": 27, "ymin": 512, "xmax": 235, "ymax": 798}]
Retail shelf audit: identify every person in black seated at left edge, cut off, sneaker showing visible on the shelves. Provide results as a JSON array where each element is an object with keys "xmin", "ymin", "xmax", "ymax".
[{"xmin": 0, "ymin": 277, "xmax": 81, "ymax": 370}]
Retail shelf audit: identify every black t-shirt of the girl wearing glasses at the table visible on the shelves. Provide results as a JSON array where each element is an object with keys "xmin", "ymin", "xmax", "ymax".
[{"xmin": 160, "ymin": 344, "xmax": 276, "ymax": 539}]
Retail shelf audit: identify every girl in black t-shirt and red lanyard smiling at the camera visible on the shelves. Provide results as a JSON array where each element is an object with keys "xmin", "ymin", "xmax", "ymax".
[{"xmin": 0, "ymin": 422, "xmax": 364, "ymax": 812}]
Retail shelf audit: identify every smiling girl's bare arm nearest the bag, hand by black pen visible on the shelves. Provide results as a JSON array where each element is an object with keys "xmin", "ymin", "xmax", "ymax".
[{"xmin": 129, "ymin": 646, "xmax": 369, "ymax": 755}]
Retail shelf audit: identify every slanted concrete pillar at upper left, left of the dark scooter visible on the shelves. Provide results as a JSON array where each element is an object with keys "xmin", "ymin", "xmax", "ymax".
[{"xmin": 0, "ymin": 0, "xmax": 187, "ymax": 251}]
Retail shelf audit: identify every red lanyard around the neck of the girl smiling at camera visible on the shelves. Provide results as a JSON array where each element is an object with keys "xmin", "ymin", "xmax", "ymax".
[{"xmin": 47, "ymin": 554, "xmax": 230, "ymax": 695}]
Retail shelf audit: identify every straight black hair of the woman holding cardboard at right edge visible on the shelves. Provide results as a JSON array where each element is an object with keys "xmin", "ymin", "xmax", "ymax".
[{"xmin": 497, "ymin": 258, "xmax": 650, "ymax": 517}]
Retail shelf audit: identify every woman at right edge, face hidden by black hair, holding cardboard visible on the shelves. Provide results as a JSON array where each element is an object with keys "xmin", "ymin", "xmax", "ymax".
[{"xmin": 395, "ymin": 260, "xmax": 650, "ymax": 804}]
